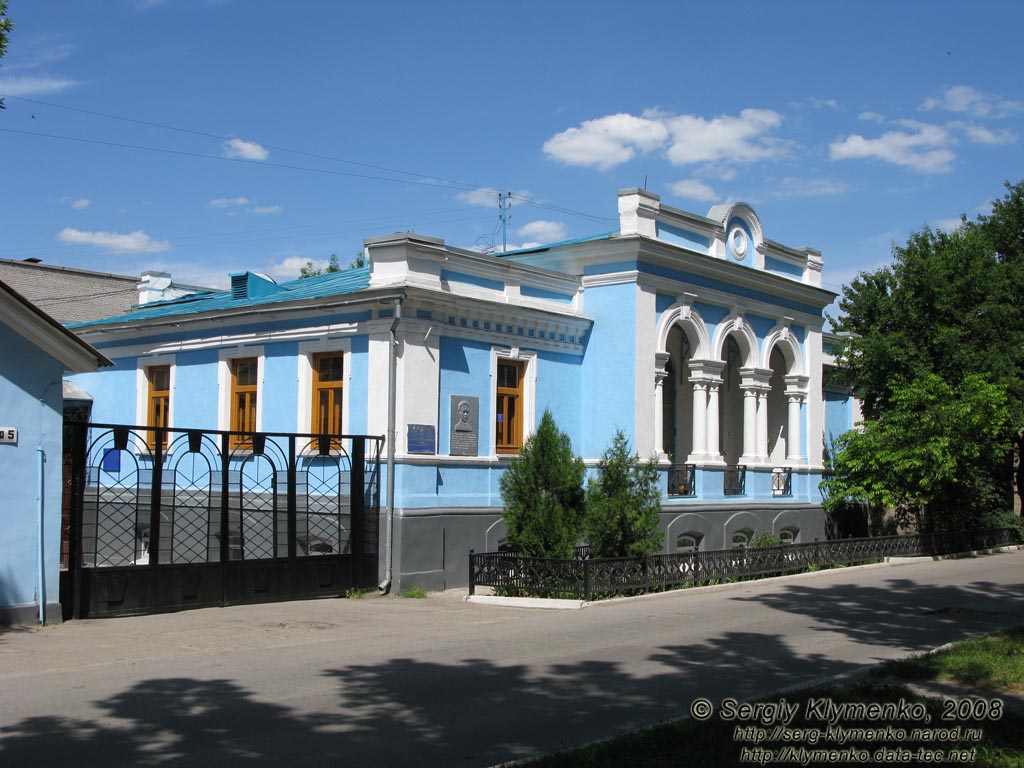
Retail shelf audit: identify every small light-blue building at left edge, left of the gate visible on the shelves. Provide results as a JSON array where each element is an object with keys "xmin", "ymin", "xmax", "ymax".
[{"xmin": 0, "ymin": 282, "xmax": 111, "ymax": 624}]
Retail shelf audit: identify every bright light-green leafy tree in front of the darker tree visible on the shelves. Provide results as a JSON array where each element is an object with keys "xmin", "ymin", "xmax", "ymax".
[{"xmin": 824, "ymin": 374, "xmax": 1009, "ymax": 531}]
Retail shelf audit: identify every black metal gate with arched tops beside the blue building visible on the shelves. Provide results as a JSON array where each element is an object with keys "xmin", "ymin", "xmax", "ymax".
[{"xmin": 60, "ymin": 422, "xmax": 383, "ymax": 618}]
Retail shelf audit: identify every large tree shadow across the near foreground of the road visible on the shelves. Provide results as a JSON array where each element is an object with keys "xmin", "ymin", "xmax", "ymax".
[{"xmin": 0, "ymin": 628, "xmax": 848, "ymax": 768}]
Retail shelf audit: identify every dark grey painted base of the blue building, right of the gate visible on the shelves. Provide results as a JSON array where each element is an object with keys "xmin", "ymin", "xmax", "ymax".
[{"xmin": 381, "ymin": 503, "xmax": 826, "ymax": 593}]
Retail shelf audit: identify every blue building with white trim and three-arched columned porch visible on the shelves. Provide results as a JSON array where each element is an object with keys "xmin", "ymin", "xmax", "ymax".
[{"xmin": 68, "ymin": 189, "xmax": 857, "ymax": 589}]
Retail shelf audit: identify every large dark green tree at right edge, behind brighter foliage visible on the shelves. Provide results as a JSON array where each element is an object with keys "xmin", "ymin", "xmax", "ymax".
[{"xmin": 834, "ymin": 183, "xmax": 1024, "ymax": 525}]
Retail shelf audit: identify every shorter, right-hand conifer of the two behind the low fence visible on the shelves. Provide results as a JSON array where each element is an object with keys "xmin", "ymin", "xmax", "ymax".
[{"xmin": 586, "ymin": 429, "xmax": 665, "ymax": 557}]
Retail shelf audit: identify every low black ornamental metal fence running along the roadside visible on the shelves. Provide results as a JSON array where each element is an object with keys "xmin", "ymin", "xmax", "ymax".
[{"xmin": 469, "ymin": 528, "xmax": 1020, "ymax": 601}]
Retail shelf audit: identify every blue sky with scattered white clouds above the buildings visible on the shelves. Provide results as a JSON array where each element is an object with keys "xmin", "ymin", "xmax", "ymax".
[{"xmin": 0, "ymin": 0, "xmax": 1024, "ymax": 307}]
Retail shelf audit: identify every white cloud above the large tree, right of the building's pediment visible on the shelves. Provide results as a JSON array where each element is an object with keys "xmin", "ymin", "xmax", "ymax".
[{"xmin": 828, "ymin": 120, "xmax": 956, "ymax": 173}]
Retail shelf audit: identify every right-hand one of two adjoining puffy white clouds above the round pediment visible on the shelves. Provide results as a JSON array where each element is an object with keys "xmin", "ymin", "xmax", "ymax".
[{"xmin": 665, "ymin": 110, "xmax": 790, "ymax": 165}]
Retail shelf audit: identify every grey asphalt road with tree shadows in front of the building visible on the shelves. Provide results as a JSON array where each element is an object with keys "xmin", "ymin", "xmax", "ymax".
[{"xmin": 0, "ymin": 551, "xmax": 1024, "ymax": 768}]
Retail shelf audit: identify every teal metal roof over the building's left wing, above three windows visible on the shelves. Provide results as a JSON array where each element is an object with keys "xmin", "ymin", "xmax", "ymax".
[{"xmin": 68, "ymin": 266, "xmax": 370, "ymax": 329}]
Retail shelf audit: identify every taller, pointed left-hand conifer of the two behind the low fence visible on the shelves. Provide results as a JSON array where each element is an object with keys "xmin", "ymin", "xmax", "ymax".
[{"xmin": 500, "ymin": 411, "xmax": 586, "ymax": 557}]
